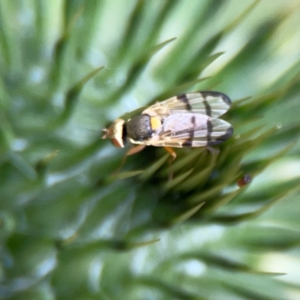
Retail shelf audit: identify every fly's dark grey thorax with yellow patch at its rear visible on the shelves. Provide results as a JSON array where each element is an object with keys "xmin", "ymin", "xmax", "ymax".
[{"xmin": 126, "ymin": 114, "xmax": 161, "ymax": 141}]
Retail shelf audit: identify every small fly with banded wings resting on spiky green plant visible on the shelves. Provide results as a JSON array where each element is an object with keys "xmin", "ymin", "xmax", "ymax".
[{"xmin": 102, "ymin": 92, "xmax": 233, "ymax": 158}]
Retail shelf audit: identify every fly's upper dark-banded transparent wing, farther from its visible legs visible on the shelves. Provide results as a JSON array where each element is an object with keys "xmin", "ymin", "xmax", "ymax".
[{"xmin": 142, "ymin": 92, "xmax": 231, "ymax": 118}]
